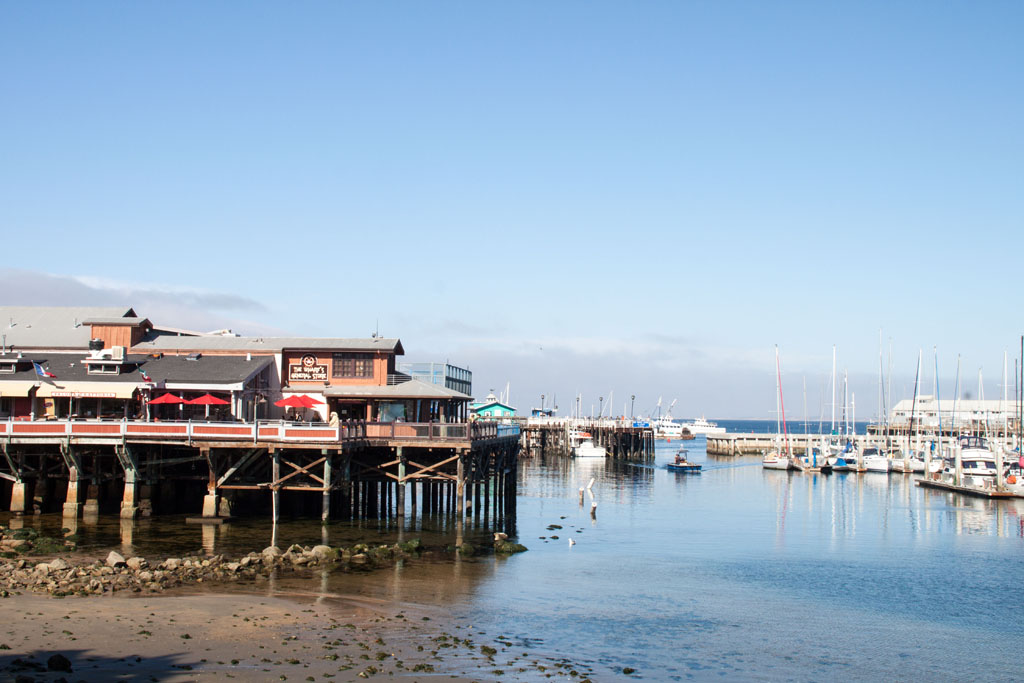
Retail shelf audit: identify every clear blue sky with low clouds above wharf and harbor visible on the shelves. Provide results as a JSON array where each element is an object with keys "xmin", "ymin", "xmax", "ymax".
[{"xmin": 0, "ymin": 2, "xmax": 1024, "ymax": 417}]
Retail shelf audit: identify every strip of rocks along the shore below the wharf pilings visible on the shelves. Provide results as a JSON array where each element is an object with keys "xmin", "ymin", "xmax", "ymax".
[{"xmin": 0, "ymin": 527, "xmax": 526, "ymax": 597}]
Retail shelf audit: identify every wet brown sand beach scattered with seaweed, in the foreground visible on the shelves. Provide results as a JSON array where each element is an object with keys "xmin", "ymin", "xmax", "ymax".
[{"xmin": 0, "ymin": 592, "xmax": 588, "ymax": 682}]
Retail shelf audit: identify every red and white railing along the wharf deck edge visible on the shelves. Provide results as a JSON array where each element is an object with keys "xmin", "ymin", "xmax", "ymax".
[{"xmin": 0, "ymin": 420, "xmax": 519, "ymax": 443}]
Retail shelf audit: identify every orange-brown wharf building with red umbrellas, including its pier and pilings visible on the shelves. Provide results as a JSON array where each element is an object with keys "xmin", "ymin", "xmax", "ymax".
[{"xmin": 0, "ymin": 306, "xmax": 519, "ymax": 525}]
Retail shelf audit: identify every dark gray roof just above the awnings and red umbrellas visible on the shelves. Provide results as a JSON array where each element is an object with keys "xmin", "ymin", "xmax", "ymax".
[{"xmin": 0, "ymin": 352, "xmax": 273, "ymax": 384}]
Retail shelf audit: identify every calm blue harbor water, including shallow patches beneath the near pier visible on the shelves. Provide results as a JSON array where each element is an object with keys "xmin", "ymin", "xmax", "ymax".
[{"xmin": 2, "ymin": 421, "xmax": 1024, "ymax": 681}]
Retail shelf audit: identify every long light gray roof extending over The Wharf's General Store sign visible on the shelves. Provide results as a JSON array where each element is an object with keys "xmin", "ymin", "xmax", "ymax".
[{"xmin": 132, "ymin": 331, "xmax": 406, "ymax": 355}]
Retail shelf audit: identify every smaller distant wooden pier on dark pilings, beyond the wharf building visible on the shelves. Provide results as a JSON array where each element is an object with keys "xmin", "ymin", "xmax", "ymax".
[{"xmin": 522, "ymin": 418, "xmax": 654, "ymax": 462}]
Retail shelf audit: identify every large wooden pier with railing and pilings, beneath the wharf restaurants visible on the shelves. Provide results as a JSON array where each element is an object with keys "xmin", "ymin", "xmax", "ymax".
[{"xmin": 0, "ymin": 420, "xmax": 520, "ymax": 532}]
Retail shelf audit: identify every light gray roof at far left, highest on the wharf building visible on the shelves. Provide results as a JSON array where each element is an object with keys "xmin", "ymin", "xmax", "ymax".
[{"xmin": 0, "ymin": 306, "xmax": 135, "ymax": 349}]
